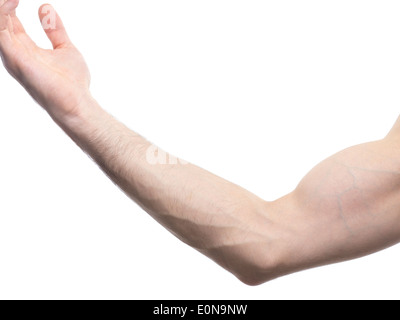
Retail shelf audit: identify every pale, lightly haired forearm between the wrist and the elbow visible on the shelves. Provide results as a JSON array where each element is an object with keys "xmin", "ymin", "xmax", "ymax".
[{"xmin": 55, "ymin": 94, "xmax": 276, "ymax": 281}]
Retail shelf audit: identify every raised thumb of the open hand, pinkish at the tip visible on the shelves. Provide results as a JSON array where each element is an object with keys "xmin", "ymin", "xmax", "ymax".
[{"xmin": 39, "ymin": 4, "xmax": 71, "ymax": 49}]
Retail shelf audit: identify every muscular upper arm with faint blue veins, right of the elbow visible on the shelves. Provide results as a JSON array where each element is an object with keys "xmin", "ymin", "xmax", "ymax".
[{"xmin": 262, "ymin": 138, "xmax": 400, "ymax": 282}]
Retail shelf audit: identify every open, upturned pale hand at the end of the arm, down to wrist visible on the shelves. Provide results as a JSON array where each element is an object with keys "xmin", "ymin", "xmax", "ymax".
[{"xmin": 0, "ymin": 0, "xmax": 90, "ymax": 121}]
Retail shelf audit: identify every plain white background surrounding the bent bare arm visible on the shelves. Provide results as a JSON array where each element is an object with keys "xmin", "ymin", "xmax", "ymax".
[{"xmin": 0, "ymin": 0, "xmax": 400, "ymax": 299}]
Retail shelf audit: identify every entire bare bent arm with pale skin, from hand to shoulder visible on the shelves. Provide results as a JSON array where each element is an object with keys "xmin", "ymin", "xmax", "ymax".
[{"xmin": 0, "ymin": 0, "xmax": 400, "ymax": 285}]
